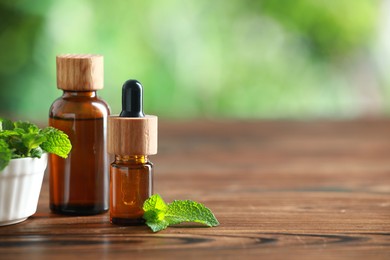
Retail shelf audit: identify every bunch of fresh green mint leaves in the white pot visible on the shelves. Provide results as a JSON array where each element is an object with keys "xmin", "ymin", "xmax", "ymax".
[{"xmin": 0, "ymin": 118, "xmax": 72, "ymax": 171}]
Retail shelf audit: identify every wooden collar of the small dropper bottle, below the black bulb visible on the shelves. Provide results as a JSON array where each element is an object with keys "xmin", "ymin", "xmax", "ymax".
[{"xmin": 107, "ymin": 115, "xmax": 157, "ymax": 155}]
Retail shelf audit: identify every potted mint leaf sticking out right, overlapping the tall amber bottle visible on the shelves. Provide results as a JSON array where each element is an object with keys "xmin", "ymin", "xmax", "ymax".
[{"xmin": 41, "ymin": 127, "xmax": 72, "ymax": 158}]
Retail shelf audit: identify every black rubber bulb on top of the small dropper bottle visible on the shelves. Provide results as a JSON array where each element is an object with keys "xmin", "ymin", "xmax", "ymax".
[{"xmin": 119, "ymin": 79, "xmax": 145, "ymax": 117}]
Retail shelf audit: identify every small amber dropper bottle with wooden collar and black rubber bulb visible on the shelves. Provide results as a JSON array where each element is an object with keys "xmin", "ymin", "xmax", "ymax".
[{"xmin": 108, "ymin": 80, "xmax": 157, "ymax": 225}]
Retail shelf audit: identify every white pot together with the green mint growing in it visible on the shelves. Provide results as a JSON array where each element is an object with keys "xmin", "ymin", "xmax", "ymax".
[{"xmin": 0, "ymin": 118, "xmax": 72, "ymax": 226}]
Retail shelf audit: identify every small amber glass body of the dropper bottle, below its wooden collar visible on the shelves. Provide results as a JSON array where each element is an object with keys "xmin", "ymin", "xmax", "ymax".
[{"xmin": 110, "ymin": 155, "xmax": 153, "ymax": 225}]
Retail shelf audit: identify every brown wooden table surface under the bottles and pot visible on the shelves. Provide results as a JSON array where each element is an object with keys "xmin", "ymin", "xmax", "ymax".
[{"xmin": 0, "ymin": 120, "xmax": 390, "ymax": 259}]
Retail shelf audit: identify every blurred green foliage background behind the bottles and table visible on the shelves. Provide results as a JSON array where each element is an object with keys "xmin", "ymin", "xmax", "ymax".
[{"xmin": 0, "ymin": 0, "xmax": 390, "ymax": 121}]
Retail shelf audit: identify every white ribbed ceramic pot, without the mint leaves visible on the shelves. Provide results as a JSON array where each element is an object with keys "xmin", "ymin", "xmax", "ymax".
[{"xmin": 0, "ymin": 154, "xmax": 47, "ymax": 226}]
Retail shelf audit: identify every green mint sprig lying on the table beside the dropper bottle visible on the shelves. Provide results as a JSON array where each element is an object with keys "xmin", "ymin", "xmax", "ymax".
[{"xmin": 143, "ymin": 194, "xmax": 219, "ymax": 232}]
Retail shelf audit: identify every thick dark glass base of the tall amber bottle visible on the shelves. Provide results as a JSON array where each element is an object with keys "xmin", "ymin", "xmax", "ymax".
[{"xmin": 50, "ymin": 204, "xmax": 108, "ymax": 216}]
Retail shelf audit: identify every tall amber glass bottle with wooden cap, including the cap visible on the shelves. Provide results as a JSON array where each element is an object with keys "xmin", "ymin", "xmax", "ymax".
[{"xmin": 48, "ymin": 55, "xmax": 110, "ymax": 215}]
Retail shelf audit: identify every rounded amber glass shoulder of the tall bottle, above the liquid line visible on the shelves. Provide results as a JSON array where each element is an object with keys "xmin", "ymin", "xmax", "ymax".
[{"xmin": 49, "ymin": 96, "xmax": 111, "ymax": 119}]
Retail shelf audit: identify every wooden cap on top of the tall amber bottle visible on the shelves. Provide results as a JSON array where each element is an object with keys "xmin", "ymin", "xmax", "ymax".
[{"xmin": 56, "ymin": 54, "xmax": 104, "ymax": 91}]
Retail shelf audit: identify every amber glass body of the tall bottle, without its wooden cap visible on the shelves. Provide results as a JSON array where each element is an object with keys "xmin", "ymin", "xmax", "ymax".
[{"xmin": 48, "ymin": 91, "xmax": 110, "ymax": 215}]
